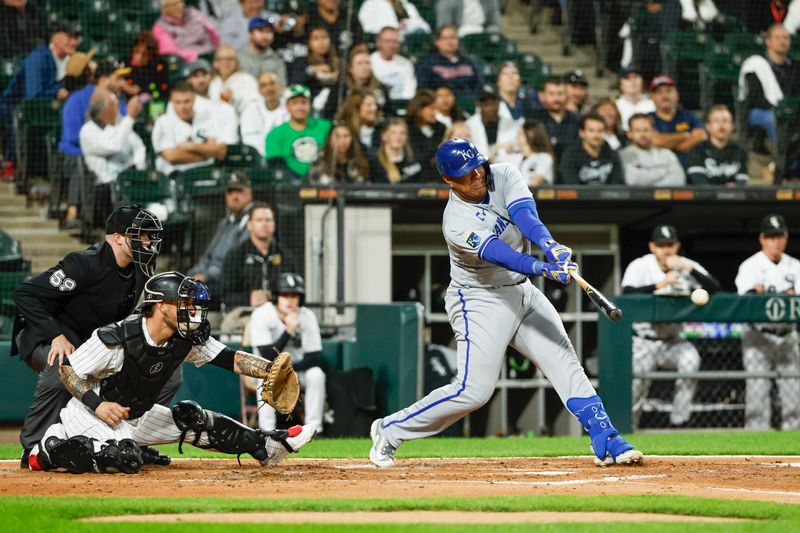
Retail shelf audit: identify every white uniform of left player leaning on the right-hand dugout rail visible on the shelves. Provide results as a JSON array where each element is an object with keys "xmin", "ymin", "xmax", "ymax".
[{"xmin": 622, "ymin": 254, "xmax": 708, "ymax": 426}]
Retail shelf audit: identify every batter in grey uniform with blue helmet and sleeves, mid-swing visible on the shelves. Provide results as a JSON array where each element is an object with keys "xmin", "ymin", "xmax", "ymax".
[{"xmin": 369, "ymin": 139, "xmax": 643, "ymax": 467}]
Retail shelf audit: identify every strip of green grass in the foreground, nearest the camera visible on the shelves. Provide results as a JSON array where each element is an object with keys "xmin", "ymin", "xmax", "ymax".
[{"xmin": 0, "ymin": 495, "xmax": 800, "ymax": 533}]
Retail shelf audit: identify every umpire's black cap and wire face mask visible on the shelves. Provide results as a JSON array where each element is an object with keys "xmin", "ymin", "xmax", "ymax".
[{"xmin": 106, "ymin": 205, "xmax": 164, "ymax": 277}]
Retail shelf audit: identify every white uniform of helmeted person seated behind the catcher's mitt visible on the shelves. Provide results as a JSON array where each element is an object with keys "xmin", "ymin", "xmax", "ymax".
[{"xmin": 250, "ymin": 302, "xmax": 325, "ymax": 433}]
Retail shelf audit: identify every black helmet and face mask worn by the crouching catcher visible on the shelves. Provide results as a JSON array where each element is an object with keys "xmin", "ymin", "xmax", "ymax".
[{"xmin": 142, "ymin": 272, "xmax": 211, "ymax": 345}]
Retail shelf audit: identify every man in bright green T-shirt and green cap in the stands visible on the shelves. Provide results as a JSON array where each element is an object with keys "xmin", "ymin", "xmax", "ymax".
[{"xmin": 266, "ymin": 84, "xmax": 331, "ymax": 178}]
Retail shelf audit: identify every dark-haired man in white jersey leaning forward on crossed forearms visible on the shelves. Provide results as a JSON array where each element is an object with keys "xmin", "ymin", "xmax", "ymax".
[{"xmin": 153, "ymin": 83, "xmax": 234, "ymax": 175}]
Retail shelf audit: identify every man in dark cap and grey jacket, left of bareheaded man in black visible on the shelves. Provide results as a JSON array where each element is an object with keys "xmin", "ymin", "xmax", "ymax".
[{"xmin": 187, "ymin": 170, "xmax": 253, "ymax": 309}]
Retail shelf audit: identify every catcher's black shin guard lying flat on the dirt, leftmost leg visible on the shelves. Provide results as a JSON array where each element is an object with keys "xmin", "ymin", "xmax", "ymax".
[{"xmin": 30, "ymin": 435, "xmax": 143, "ymax": 474}]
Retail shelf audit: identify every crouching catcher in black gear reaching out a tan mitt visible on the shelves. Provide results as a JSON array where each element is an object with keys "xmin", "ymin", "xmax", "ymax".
[{"xmin": 29, "ymin": 272, "xmax": 315, "ymax": 474}]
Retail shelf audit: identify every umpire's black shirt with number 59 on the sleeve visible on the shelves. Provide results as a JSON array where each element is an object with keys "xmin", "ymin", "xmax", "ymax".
[{"xmin": 12, "ymin": 242, "xmax": 145, "ymax": 356}]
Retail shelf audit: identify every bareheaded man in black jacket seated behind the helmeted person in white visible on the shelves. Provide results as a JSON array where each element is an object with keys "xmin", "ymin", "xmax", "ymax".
[{"xmin": 222, "ymin": 202, "xmax": 297, "ymax": 312}]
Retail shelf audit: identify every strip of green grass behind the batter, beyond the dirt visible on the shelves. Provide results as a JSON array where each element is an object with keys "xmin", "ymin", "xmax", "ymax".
[{"xmin": 0, "ymin": 431, "xmax": 800, "ymax": 459}]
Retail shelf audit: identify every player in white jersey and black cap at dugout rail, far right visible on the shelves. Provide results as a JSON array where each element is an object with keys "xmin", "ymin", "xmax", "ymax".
[{"xmin": 736, "ymin": 215, "xmax": 800, "ymax": 429}]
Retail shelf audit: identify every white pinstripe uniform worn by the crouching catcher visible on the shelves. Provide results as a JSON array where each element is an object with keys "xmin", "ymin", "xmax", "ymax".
[{"xmin": 41, "ymin": 318, "xmax": 284, "ymax": 456}]
